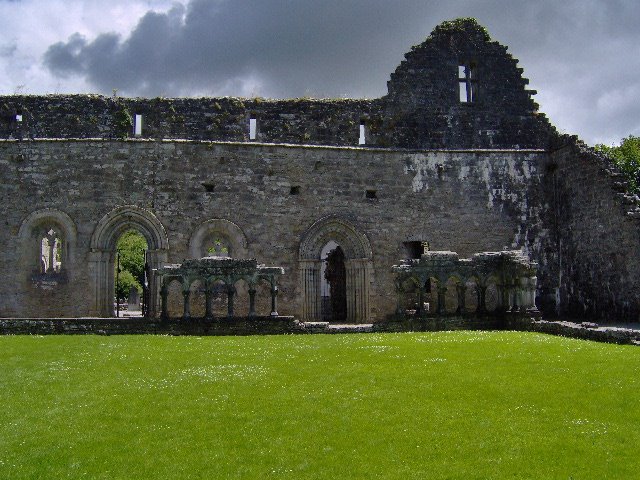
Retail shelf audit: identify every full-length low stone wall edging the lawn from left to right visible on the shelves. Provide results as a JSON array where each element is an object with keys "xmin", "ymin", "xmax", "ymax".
[{"xmin": 0, "ymin": 315, "xmax": 640, "ymax": 345}]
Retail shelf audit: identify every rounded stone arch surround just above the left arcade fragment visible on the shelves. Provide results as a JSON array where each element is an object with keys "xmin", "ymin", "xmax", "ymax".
[{"xmin": 189, "ymin": 218, "xmax": 247, "ymax": 259}]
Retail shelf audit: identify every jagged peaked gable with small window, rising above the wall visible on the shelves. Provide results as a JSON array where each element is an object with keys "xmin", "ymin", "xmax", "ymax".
[{"xmin": 385, "ymin": 18, "xmax": 552, "ymax": 148}]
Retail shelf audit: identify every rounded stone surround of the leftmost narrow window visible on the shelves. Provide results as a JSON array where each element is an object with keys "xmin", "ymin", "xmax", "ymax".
[{"xmin": 18, "ymin": 208, "xmax": 78, "ymax": 280}]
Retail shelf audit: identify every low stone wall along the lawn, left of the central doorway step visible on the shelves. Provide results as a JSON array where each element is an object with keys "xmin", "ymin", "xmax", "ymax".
[{"xmin": 0, "ymin": 316, "xmax": 306, "ymax": 335}]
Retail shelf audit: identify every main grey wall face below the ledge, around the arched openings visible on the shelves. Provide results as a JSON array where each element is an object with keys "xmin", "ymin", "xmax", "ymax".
[{"xmin": 0, "ymin": 140, "xmax": 546, "ymax": 321}]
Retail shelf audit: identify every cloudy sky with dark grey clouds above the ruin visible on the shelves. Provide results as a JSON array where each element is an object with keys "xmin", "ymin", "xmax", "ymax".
[{"xmin": 0, "ymin": 0, "xmax": 640, "ymax": 144}]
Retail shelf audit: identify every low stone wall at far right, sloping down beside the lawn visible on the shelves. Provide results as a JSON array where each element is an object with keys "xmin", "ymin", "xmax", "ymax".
[{"xmin": 505, "ymin": 318, "xmax": 640, "ymax": 345}]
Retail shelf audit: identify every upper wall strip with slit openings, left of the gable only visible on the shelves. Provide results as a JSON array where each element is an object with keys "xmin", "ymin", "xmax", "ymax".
[{"xmin": 0, "ymin": 95, "xmax": 380, "ymax": 146}]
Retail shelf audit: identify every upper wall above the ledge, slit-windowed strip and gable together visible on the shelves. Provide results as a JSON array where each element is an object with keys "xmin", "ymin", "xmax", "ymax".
[{"xmin": 0, "ymin": 19, "xmax": 553, "ymax": 149}]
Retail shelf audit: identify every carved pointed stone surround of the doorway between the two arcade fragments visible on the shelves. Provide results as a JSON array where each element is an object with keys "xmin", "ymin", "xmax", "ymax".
[{"xmin": 298, "ymin": 215, "xmax": 373, "ymax": 323}]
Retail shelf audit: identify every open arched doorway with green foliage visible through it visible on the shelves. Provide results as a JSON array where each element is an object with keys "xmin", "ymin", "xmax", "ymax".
[{"xmin": 113, "ymin": 229, "xmax": 150, "ymax": 317}]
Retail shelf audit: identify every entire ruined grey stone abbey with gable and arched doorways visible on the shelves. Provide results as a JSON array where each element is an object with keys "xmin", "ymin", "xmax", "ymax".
[{"xmin": 0, "ymin": 20, "xmax": 640, "ymax": 323}]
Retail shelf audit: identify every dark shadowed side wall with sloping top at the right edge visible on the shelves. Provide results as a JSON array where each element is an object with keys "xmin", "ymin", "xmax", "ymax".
[{"xmin": 542, "ymin": 137, "xmax": 640, "ymax": 322}]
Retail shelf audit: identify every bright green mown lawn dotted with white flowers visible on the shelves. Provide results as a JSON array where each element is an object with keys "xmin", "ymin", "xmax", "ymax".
[{"xmin": 0, "ymin": 332, "xmax": 640, "ymax": 479}]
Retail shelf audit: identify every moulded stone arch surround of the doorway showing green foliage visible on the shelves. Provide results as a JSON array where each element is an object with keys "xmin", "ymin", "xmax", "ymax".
[{"xmin": 89, "ymin": 205, "xmax": 169, "ymax": 317}]
